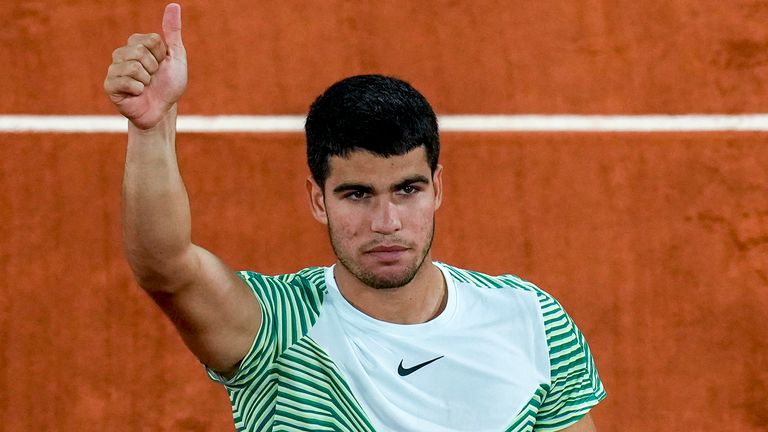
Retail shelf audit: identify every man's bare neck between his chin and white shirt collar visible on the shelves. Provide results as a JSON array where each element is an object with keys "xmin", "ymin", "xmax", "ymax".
[{"xmin": 334, "ymin": 257, "xmax": 448, "ymax": 324}]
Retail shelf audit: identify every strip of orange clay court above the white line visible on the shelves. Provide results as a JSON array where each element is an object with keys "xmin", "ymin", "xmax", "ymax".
[{"xmin": 0, "ymin": 0, "xmax": 768, "ymax": 114}]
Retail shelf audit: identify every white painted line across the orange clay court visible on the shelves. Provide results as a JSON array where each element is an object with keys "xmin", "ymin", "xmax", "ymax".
[{"xmin": 0, "ymin": 114, "xmax": 768, "ymax": 133}]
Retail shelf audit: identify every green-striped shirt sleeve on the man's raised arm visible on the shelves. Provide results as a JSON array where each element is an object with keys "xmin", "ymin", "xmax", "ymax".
[{"xmin": 206, "ymin": 271, "xmax": 321, "ymax": 388}]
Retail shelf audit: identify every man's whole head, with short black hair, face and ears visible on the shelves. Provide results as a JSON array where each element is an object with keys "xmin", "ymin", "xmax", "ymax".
[{"xmin": 306, "ymin": 75, "xmax": 442, "ymax": 288}]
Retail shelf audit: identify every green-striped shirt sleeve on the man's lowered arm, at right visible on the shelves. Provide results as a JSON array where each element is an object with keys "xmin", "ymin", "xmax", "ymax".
[{"xmin": 534, "ymin": 294, "xmax": 606, "ymax": 431}]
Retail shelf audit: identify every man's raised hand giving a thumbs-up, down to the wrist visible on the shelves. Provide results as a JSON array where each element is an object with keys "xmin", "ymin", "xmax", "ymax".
[{"xmin": 104, "ymin": 3, "xmax": 187, "ymax": 129}]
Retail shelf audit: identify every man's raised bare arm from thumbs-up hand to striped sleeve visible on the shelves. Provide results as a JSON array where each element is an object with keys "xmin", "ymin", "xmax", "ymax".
[{"xmin": 104, "ymin": 4, "xmax": 261, "ymax": 374}]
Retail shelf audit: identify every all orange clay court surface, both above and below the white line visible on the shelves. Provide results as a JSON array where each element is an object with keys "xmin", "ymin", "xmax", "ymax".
[{"xmin": 0, "ymin": 0, "xmax": 768, "ymax": 432}]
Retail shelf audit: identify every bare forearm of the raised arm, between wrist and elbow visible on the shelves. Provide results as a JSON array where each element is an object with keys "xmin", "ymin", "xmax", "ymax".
[{"xmin": 123, "ymin": 106, "xmax": 191, "ymax": 290}]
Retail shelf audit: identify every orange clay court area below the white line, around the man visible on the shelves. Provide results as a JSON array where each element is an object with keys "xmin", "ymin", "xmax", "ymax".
[{"xmin": 0, "ymin": 134, "xmax": 768, "ymax": 431}]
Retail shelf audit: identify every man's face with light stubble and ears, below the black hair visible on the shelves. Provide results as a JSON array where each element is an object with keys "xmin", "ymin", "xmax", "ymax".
[{"xmin": 308, "ymin": 147, "xmax": 442, "ymax": 288}]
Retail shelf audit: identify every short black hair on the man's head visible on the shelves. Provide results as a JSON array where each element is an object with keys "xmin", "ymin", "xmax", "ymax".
[{"xmin": 304, "ymin": 75, "xmax": 440, "ymax": 187}]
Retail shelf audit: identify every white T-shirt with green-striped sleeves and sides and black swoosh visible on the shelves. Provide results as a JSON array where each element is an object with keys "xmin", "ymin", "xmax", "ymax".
[{"xmin": 208, "ymin": 263, "xmax": 606, "ymax": 432}]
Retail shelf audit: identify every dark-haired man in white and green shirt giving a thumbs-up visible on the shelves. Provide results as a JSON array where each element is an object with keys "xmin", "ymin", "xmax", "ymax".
[{"xmin": 104, "ymin": 4, "xmax": 605, "ymax": 432}]
